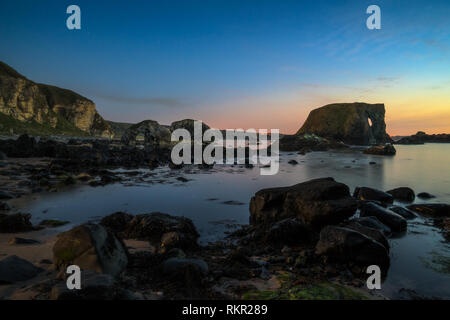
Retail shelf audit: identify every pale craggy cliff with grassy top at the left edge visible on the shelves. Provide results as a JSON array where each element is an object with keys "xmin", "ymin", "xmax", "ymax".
[{"xmin": 0, "ymin": 62, "xmax": 112, "ymax": 137}]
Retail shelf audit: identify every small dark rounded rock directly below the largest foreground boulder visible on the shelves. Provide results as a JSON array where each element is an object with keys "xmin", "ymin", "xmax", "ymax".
[{"xmin": 266, "ymin": 218, "xmax": 311, "ymax": 245}]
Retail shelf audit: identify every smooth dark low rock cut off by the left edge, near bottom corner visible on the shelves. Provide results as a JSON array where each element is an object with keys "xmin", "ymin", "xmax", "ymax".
[{"xmin": 0, "ymin": 255, "xmax": 43, "ymax": 284}]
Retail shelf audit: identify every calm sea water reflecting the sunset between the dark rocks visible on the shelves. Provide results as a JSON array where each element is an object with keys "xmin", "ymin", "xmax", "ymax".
[{"xmin": 9, "ymin": 144, "xmax": 450, "ymax": 299}]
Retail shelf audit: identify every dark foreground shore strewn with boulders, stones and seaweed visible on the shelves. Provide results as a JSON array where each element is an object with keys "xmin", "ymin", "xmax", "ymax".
[{"xmin": 0, "ymin": 159, "xmax": 450, "ymax": 299}]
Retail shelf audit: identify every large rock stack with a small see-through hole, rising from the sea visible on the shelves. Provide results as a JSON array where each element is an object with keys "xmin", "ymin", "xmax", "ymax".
[{"xmin": 297, "ymin": 102, "xmax": 392, "ymax": 145}]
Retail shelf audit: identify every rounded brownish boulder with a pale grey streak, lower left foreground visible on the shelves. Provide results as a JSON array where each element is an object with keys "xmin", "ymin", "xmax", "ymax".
[{"xmin": 53, "ymin": 223, "xmax": 128, "ymax": 276}]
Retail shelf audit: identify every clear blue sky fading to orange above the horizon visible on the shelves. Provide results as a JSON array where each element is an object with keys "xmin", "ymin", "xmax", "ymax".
[{"xmin": 0, "ymin": 0, "xmax": 450, "ymax": 135}]
